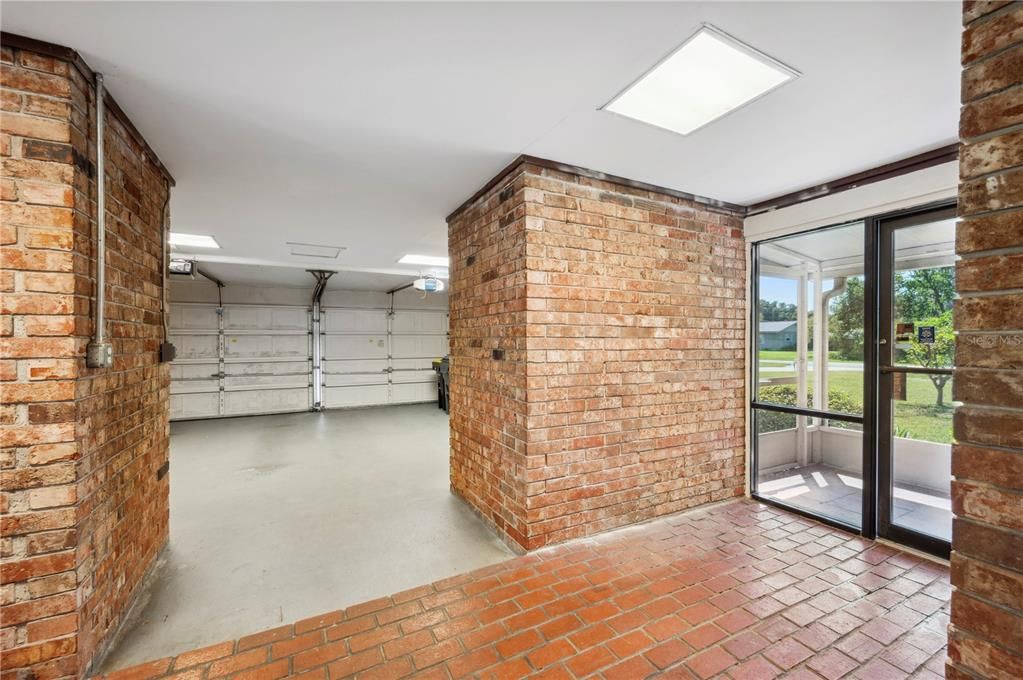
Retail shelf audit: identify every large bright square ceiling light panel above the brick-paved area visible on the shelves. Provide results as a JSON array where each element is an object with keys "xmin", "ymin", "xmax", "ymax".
[{"xmin": 604, "ymin": 25, "xmax": 799, "ymax": 135}]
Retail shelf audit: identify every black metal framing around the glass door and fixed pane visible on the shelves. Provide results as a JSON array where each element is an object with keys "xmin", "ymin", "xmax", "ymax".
[{"xmin": 748, "ymin": 199, "xmax": 955, "ymax": 557}]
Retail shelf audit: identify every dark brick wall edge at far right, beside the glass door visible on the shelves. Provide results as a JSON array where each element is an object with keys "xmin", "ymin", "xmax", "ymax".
[{"xmin": 946, "ymin": 2, "xmax": 1023, "ymax": 679}]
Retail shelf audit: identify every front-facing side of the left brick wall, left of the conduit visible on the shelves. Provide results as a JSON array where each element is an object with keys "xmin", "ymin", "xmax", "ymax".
[{"xmin": 0, "ymin": 47, "xmax": 81, "ymax": 677}]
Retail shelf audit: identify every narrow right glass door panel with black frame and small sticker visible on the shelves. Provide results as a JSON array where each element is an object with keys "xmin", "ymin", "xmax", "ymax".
[{"xmin": 878, "ymin": 209, "xmax": 955, "ymax": 553}]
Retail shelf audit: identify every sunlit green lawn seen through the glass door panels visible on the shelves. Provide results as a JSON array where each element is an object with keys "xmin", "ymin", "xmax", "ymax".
[{"xmin": 760, "ymin": 352, "xmax": 953, "ymax": 444}]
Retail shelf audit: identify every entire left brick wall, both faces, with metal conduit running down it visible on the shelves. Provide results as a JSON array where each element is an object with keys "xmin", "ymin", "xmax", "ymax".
[{"xmin": 0, "ymin": 36, "xmax": 170, "ymax": 678}]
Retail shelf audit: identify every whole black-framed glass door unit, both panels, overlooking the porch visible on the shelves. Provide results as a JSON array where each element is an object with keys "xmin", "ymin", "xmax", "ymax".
[{"xmin": 751, "ymin": 201, "xmax": 954, "ymax": 554}]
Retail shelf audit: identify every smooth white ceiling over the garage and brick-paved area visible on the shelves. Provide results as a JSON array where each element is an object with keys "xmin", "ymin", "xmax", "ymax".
[{"xmin": 3, "ymin": 2, "xmax": 962, "ymax": 286}]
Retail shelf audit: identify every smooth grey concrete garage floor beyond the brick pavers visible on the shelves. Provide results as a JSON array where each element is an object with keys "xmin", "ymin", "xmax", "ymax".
[{"xmin": 102, "ymin": 404, "xmax": 514, "ymax": 672}]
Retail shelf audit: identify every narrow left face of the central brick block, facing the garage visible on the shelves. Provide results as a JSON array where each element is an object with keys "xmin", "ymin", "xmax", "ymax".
[{"xmin": 448, "ymin": 168, "xmax": 527, "ymax": 545}]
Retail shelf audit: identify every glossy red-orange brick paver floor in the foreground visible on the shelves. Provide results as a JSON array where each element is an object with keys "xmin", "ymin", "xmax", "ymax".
[{"xmin": 96, "ymin": 500, "xmax": 949, "ymax": 680}]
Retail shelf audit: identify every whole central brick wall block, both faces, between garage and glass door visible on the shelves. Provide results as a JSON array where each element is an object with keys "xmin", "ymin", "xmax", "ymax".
[{"xmin": 448, "ymin": 161, "xmax": 746, "ymax": 549}]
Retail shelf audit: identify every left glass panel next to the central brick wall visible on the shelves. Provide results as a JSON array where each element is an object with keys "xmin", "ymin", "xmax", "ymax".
[{"xmin": 752, "ymin": 222, "xmax": 870, "ymax": 531}]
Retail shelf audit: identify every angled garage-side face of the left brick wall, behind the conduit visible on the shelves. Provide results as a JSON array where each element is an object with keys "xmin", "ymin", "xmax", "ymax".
[{"xmin": 72, "ymin": 47, "xmax": 170, "ymax": 665}]
